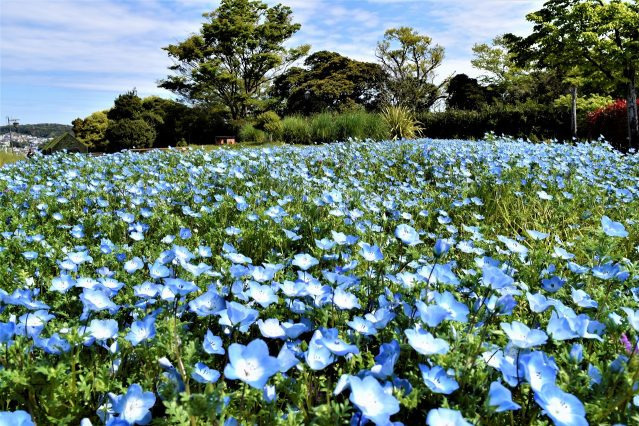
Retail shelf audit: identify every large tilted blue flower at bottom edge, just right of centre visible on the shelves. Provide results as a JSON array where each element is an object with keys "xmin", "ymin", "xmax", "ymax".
[{"xmin": 349, "ymin": 376, "xmax": 399, "ymax": 425}]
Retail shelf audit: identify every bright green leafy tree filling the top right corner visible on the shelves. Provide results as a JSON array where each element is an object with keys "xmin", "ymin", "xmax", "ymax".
[{"xmin": 509, "ymin": 0, "xmax": 639, "ymax": 146}]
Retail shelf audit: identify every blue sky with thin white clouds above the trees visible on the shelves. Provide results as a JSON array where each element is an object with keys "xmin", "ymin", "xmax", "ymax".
[{"xmin": 0, "ymin": 0, "xmax": 543, "ymax": 123}]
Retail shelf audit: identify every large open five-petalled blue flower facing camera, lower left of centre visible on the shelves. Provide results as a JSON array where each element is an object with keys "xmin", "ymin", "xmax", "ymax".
[{"xmin": 224, "ymin": 339, "xmax": 280, "ymax": 389}]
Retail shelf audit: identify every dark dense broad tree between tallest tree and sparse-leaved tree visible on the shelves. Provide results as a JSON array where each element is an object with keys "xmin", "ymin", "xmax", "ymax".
[{"xmin": 271, "ymin": 51, "xmax": 384, "ymax": 114}]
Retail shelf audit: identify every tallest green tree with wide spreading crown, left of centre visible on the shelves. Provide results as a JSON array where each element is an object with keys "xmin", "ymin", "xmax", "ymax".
[{"xmin": 159, "ymin": 0, "xmax": 310, "ymax": 120}]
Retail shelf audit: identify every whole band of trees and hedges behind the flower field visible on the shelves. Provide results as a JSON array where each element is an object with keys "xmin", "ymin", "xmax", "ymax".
[{"xmin": 73, "ymin": 0, "xmax": 639, "ymax": 151}]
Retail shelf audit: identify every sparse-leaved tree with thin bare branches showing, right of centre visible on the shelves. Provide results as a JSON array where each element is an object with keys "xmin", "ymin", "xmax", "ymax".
[{"xmin": 375, "ymin": 27, "xmax": 450, "ymax": 109}]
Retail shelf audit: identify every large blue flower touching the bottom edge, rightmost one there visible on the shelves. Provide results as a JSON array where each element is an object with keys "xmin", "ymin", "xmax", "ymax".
[{"xmin": 535, "ymin": 384, "xmax": 588, "ymax": 426}]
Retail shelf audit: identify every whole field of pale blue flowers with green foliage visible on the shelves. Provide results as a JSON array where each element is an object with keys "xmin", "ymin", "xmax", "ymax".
[{"xmin": 0, "ymin": 140, "xmax": 639, "ymax": 426}]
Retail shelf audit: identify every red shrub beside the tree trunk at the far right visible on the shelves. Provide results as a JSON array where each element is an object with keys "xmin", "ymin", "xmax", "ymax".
[{"xmin": 586, "ymin": 99, "xmax": 639, "ymax": 148}]
